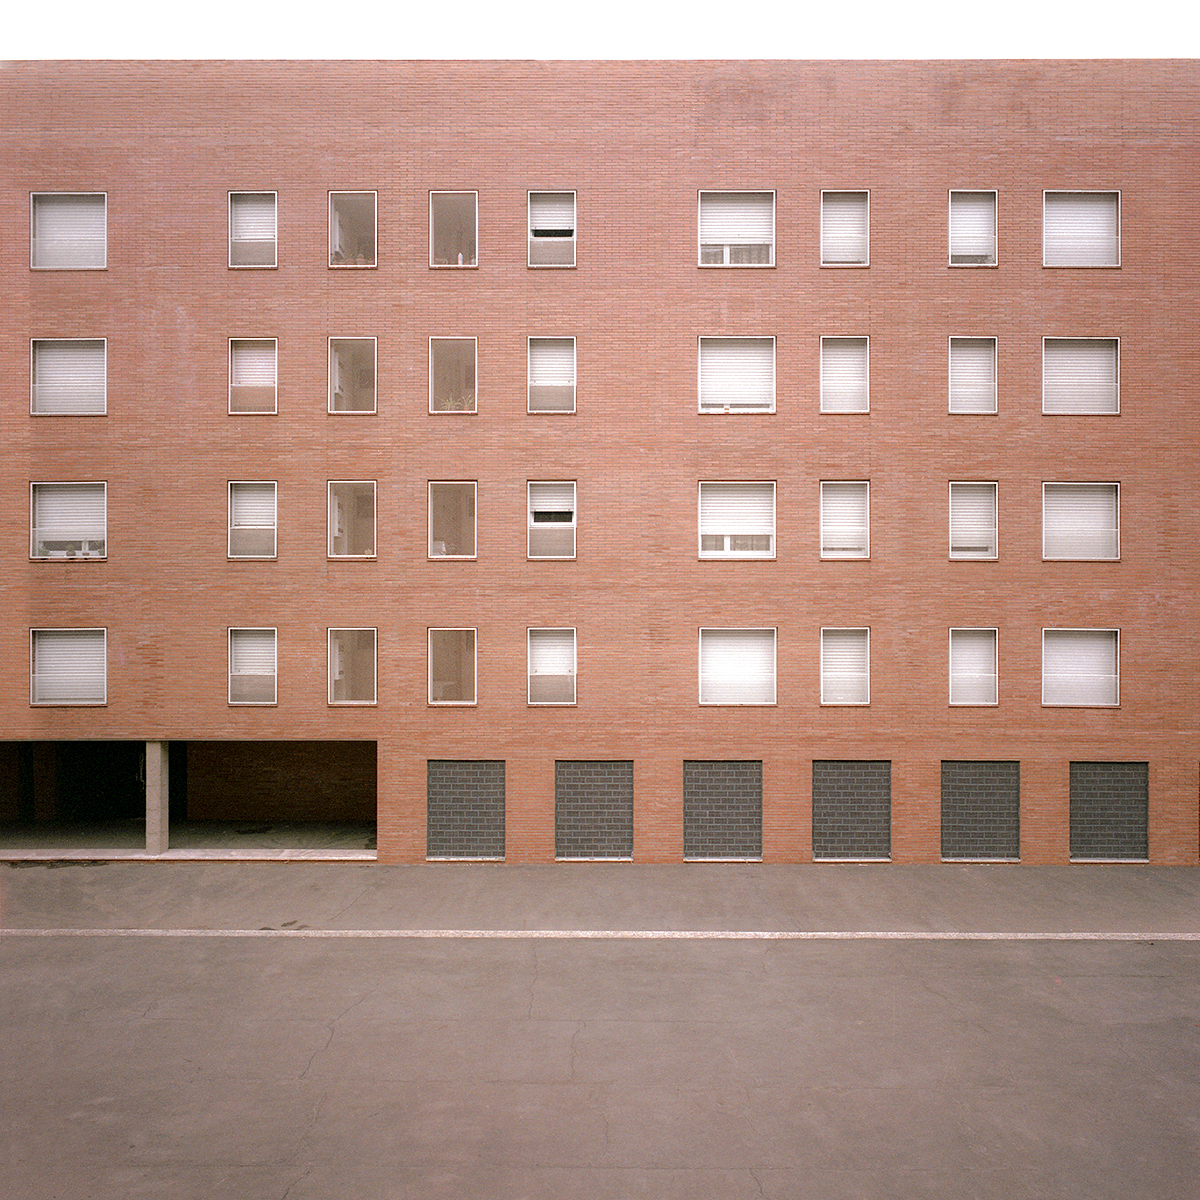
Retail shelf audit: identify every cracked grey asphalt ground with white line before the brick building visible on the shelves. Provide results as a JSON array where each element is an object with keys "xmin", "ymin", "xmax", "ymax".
[{"xmin": 0, "ymin": 862, "xmax": 1200, "ymax": 1200}]
